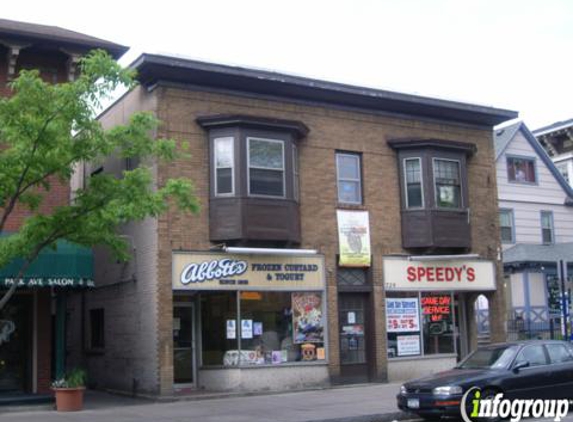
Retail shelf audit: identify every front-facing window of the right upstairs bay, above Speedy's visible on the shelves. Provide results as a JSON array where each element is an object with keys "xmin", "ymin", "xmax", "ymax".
[{"xmin": 434, "ymin": 158, "xmax": 462, "ymax": 208}]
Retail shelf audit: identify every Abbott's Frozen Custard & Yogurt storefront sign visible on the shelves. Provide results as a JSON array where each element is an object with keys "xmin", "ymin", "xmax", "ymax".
[{"xmin": 172, "ymin": 252, "xmax": 325, "ymax": 290}]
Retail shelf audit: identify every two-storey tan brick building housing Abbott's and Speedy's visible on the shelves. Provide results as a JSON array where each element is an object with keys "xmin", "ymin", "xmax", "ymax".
[{"xmin": 68, "ymin": 55, "xmax": 516, "ymax": 395}]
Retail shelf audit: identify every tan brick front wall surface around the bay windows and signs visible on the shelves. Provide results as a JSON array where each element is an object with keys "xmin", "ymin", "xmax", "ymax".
[{"xmin": 151, "ymin": 87, "xmax": 503, "ymax": 393}]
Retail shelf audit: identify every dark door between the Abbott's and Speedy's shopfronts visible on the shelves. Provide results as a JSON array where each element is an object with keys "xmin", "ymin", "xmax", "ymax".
[{"xmin": 338, "ymin": 293, "xmax": 368, "ymax": 382}]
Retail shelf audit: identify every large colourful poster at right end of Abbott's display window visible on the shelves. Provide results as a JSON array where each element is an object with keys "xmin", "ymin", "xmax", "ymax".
[{"xmin": 292, "ymin": 293, "xmax": 324, "ymax": 344}]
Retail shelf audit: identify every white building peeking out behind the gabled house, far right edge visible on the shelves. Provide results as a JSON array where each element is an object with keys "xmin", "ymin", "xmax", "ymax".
[{"xmin": 532, "ymin": 119, "xmax": 573, "ymax": 186}]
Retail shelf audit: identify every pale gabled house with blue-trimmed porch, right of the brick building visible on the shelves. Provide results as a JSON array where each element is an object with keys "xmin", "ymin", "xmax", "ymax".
[{"xmin": 495, "ymin": 122, "xmax": 573, "ymax": 330}]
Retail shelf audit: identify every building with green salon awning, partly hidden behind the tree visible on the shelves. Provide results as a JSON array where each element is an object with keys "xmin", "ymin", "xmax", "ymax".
[{"xmin": 0, "ymin": 19, "xmax": 126, "ymax": 406}]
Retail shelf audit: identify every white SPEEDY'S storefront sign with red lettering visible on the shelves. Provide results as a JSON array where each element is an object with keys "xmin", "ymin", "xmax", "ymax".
[{"xmin": 384, "ymin": 258, "xmax": 495, "ymax": 291}]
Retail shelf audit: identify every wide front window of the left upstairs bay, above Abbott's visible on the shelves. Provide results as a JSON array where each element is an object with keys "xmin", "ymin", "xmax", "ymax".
[{"xmin": 247, "ymin": 138, "xmax": 285, "ymax": 197}]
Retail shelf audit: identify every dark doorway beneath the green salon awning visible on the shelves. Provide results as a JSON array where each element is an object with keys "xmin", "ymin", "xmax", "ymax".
[{"xmin": 0, "ymin": 294, "xmax": 34, "ymax": 394}]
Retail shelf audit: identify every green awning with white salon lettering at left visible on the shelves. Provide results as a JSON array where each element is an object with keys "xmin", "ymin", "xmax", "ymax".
[{"xmin": 0, "ymin": 240, "xmax": 94, "ymax": 288}]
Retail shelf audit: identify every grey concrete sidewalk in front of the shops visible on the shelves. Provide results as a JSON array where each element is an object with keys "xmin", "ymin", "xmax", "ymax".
[{"xmin": 0, "ymin": 384, "xmax": 411, "ymax": 422}]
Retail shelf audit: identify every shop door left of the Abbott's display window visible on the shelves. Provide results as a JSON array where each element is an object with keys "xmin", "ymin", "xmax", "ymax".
[{"xmin": 173, "ymin": 303, "xmax": 196, "ymax": 386}]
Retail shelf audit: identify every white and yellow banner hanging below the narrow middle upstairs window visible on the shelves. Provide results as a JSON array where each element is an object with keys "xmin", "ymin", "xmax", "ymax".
[{"xmin": 336, "ymin": 210, "xmax": 370, "ymax": 267}]
